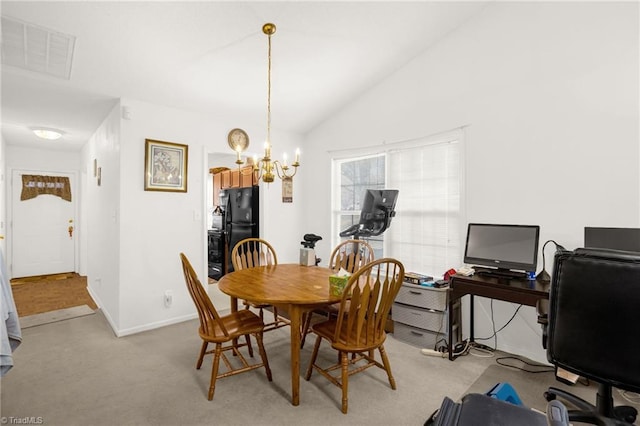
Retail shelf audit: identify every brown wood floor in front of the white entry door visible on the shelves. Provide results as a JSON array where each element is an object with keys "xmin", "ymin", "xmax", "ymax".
[{"xmin": 11, "ymin": 273, "xmax": 98, "ymax": 317}]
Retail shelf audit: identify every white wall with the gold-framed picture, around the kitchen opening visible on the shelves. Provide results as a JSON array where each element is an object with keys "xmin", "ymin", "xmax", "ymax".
[{"xmin": 83, "ymin": 99, "xmax": 308, "ymax": 335}]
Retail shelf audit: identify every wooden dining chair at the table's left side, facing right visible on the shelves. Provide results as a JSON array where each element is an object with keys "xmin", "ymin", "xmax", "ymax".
[{"xmin": 180, "ymin": 253, "xmax": 272, "ymax": 401}]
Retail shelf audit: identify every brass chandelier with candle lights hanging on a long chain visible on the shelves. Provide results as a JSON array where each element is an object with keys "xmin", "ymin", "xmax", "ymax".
[{"xmin": 235, "ymin": 23, "xmax": 300, "ymax": 183}]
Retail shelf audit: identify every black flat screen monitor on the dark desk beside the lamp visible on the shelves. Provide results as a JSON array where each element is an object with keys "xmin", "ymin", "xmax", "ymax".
[{"xmin": 464, "ymin": 223, "xmax": 540, "ymax": 272}]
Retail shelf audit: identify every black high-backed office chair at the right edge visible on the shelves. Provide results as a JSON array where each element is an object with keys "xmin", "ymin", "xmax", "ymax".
[{"xmin": 545, "ymin": 249, "xmax": 640, "ymax": 425}]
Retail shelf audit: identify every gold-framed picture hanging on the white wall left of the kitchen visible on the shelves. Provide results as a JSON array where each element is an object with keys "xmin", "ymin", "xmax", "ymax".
[{"xmin": 144, "ymin": 139, "xmax": 189, "ymax": 192}]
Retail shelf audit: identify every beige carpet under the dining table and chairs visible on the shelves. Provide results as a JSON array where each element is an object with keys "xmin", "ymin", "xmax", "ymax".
[{"xmin": 0, "ymin": 310, "xmax": 492, "ymax": 426}]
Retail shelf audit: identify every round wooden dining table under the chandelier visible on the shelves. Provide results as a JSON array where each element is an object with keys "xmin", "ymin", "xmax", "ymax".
[{"xmin": 218, "ymin": 264, "xmax": 341, "ymax": 405}]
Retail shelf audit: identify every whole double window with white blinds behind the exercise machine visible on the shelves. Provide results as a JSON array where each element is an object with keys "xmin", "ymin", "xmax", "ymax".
[{"xmin": 332, "ymin": 132, "xmax": 464, "ymax": 277}]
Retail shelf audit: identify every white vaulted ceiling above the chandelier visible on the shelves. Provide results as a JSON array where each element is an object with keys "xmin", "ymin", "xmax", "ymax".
[{"xmin": 1, "ymin": 0, "xmax": 486, "ymax": 150}]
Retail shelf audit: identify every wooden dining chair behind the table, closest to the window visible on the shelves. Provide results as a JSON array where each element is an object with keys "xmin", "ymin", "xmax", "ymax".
[{"xmin": 300, "ymin": 240, "xmax": 374, "ymax": 347}]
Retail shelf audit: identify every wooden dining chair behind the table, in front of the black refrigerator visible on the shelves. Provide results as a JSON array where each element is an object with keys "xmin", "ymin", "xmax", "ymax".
[{"xmin": 231, "ymin": 238, "xmax": 291, "ymax": 331}]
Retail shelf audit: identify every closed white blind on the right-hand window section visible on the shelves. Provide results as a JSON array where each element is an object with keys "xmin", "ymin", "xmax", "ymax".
[{"xmin": 387, "ymin": 142, "xmax": 462, "ymax": 276}]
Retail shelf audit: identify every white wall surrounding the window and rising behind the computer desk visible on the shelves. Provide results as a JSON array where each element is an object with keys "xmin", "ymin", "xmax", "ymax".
[{"xmin": 302, "ymin": 2, "xmax": 640, "ymax": 361}]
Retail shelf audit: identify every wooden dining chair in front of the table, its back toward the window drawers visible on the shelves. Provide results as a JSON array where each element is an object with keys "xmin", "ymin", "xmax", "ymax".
[{"xmin": 305, "ymin": 258, "xmax": 404, "ymax": 414}]
